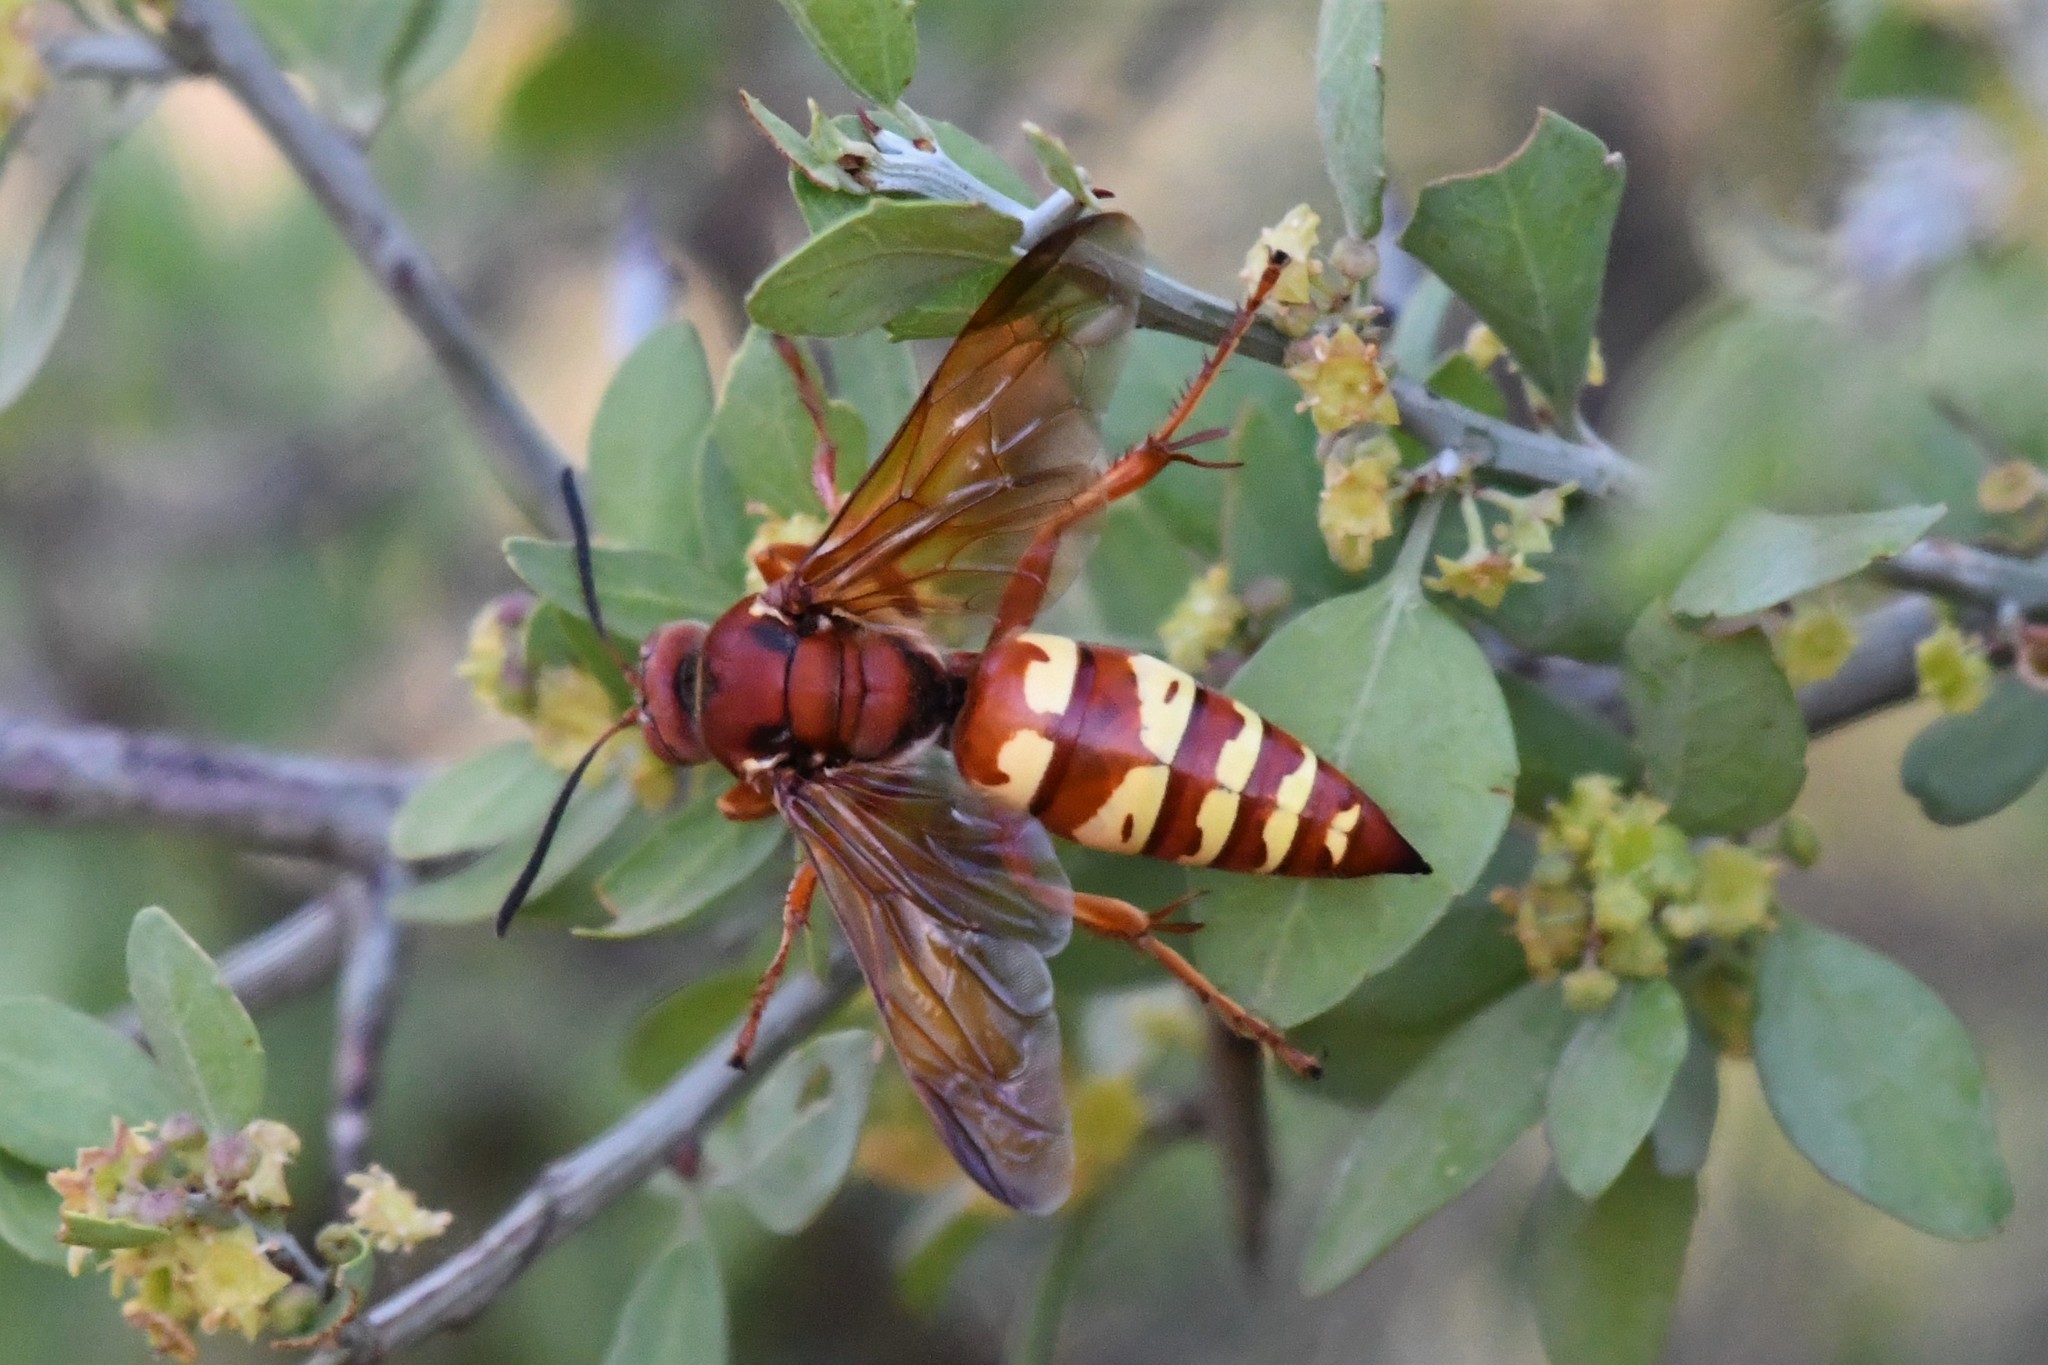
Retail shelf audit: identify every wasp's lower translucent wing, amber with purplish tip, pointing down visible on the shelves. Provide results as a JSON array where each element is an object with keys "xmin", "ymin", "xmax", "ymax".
[{"xmin": 778, "ymin": 749, "xmax": 1073, "ymax": 1212}]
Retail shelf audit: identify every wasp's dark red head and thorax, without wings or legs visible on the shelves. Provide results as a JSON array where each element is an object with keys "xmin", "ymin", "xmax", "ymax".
[{"xmin": 641, "ymin": 598, "xmax": 958, "ymax": 778}]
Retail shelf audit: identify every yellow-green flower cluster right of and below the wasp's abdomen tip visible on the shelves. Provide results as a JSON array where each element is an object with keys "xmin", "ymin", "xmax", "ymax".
[{"xmin": 1493, "ymin": 776, "xmax": 1778, "ymax": 1011}]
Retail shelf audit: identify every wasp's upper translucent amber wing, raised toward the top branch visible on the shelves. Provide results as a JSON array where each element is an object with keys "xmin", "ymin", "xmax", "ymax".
[{"xmin": 770, "ymin": 213, "xmax": 1145, "ymax": 636}]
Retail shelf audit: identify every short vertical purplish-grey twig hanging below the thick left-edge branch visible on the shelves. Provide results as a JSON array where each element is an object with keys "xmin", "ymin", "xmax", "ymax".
[{"xmin": 328, "ymin": 862, "xmax": 410, "ymax": 1197}]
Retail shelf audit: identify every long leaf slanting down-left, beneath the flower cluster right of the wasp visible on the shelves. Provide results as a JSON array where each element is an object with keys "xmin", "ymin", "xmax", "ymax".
[{"xmin": 1303, "ymin": 982, "xmax": 1577, "ymax": 1293}]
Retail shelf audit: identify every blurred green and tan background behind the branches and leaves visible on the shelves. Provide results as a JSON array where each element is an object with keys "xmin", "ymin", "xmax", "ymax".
[{"xmin": 0, "ymin": 0, "xmax": 2048, "ymax": 1365}]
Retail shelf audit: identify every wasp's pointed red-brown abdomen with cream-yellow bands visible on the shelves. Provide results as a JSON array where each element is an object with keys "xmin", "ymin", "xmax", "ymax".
[{"xmin": 952, "ymin": 634, "xmax": 1430, "ymax": 876}]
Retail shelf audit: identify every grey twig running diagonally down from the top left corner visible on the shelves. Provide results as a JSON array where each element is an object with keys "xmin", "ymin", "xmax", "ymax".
[{"xmin": 152, "ymin": 0, "xmax": 567, "ymax": 534}]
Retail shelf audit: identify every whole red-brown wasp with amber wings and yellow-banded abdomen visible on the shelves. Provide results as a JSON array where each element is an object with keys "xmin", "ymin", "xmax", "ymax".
[{"xmin": 498, "ymin": 213, "xmax": 1427, "ymax": 1212}]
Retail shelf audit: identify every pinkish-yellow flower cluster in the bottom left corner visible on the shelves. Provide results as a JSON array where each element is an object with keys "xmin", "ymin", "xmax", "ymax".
[{"xmin": 49, "ymin": 1115, "xmax": 449, "ymax": 1363}]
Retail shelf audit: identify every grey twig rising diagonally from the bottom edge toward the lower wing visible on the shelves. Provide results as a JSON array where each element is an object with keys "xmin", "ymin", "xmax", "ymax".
[{"xmin": 313, "ymin": 962, "xmax": 860, "ymax": 1365}]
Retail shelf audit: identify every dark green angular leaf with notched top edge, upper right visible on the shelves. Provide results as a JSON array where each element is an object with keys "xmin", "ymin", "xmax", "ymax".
[{"xmin": 1401, "ymin": 108, "xmax": 1622, "ymax": 422}]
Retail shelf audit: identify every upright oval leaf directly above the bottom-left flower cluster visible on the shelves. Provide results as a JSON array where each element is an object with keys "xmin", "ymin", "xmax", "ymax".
[{"xmin": 127, "ymin": 905, "xmax": 264, "ymax": 1134}]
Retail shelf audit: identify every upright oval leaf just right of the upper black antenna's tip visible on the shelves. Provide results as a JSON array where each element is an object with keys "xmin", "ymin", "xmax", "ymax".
[{"xmin": 588, "ymin": 321, "xmax": 717, "ymax": 560}]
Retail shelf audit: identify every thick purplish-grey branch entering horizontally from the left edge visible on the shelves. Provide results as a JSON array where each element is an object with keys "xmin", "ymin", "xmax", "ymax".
[{"xmin": 0, "ymin": 714, "xmax": 418, "ymax": 870}]
